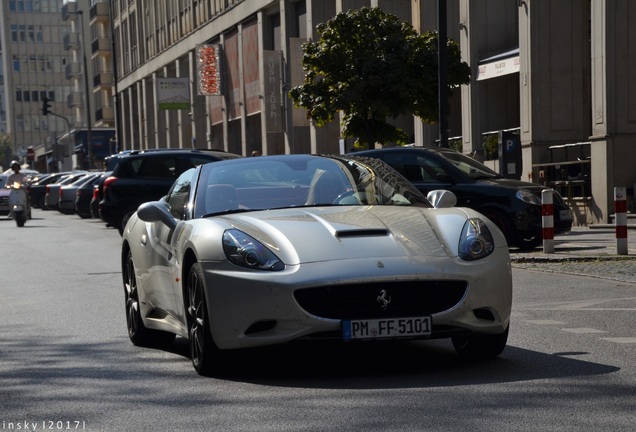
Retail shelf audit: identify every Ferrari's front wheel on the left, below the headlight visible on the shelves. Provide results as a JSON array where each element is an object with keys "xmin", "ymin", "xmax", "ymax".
[{"xmin": 186, "ymin": 263, "xmax": 219, "ymax": 376}]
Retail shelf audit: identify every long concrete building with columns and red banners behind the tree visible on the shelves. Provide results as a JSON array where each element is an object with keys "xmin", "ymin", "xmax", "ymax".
[{"xmin": 111, "ymin": 0, "xmax": 636, "ymax": 224}]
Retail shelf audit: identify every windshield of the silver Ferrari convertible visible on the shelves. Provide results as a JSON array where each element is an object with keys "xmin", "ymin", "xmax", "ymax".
[{"xmin": 195, "ymin": 155, "xmax": 430, "ymax": 217}]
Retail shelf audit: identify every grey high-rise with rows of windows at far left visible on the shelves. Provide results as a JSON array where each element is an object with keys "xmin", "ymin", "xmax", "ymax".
[{"xmin": 0, "ymin": 0, "xmax": 71, "ymax": 172}]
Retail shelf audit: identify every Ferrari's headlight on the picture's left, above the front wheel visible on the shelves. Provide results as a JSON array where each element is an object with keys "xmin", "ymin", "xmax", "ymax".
[{"xmin": 223, "ymin": 229, "xmax": 285, "ymax": 271}]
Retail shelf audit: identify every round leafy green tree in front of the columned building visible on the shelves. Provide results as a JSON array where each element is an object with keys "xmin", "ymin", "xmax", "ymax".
[{"xmin": 290, "ymin": 7, "xmax": 470, "ymax": 147}]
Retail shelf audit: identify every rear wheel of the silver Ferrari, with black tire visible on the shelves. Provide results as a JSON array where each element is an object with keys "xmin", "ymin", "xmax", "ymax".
[{"xmin": 123, "ymin": 251, "xmax": 175, "ymax": 347}]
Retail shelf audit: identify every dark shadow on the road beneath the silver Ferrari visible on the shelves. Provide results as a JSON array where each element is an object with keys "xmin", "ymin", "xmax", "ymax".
[{"xmin": 165, "ymin": 339, "xmax": 619, "ymax": 389}]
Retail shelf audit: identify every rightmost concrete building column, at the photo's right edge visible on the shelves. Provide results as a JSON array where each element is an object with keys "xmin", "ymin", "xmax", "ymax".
[{"xmin": 590, "ymin": 0, "xmax": 636, "ymax": 223}]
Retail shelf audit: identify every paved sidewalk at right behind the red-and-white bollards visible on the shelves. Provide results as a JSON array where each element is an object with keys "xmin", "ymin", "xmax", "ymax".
[{"xmin": 510, "ymin": 224, "xmax": 636, "ymax": 262}]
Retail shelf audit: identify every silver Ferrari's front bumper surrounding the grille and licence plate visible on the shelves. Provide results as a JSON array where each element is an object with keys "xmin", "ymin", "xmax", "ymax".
[{"xmin": 202, "ymin": 248, "xmax": 512, "ymax": 349}]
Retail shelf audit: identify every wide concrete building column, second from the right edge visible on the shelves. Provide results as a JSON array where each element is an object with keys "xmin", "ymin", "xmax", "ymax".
[{"xmin": 518, "ymin": 0, "xmax": 591, "ymax": 210}]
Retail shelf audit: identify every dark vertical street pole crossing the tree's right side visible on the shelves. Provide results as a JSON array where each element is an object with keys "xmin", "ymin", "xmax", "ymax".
[{"xmin": 437, "ymin": 0, "xmax": 448, "ymax": 147}]
